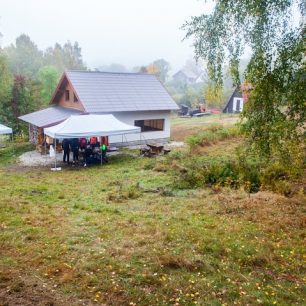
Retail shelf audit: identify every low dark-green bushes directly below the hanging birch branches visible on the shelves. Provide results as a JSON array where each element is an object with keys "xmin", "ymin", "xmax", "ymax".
[{"xmin": 170, "ymin": 142, "xmax": 293, "ymax": 196}]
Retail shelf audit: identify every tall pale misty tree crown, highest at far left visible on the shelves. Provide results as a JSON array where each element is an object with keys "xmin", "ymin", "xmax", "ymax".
[{"xmin": 4, "ymin": 34, "xmax": 42, "ymax": 78}]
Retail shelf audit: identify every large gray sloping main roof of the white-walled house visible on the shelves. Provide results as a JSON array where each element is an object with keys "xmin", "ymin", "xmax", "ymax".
[{"xmin": 66, "ymin": 71, "xmax": 178, "ymax": 113}]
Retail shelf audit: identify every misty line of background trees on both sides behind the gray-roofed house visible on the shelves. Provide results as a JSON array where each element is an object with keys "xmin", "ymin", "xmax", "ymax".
[{"xmin": 0, "ymin": 34, "xmax": 244, "ymax": 132}]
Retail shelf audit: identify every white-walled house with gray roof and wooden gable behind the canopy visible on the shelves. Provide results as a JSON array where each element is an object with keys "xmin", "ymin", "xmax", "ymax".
[{"xmin": 19, "ymin": 70, "xmax": 178, "ymax": 146}]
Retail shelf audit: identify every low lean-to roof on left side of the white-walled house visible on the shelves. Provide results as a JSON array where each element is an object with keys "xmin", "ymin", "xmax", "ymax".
[{"xmin": 18, "ymin": 106, "xmax": 82, "ymax": 127}]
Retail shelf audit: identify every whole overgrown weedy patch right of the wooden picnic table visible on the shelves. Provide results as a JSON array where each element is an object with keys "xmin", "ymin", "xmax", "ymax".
[{"xmin": 158, "ymin": 124, "xmax": 305, "ymax": 196}]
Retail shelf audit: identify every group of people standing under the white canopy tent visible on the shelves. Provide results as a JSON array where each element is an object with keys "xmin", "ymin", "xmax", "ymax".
[{"xmin": 62, "ymin": 137, "xmax": 108, "ymax": 167}]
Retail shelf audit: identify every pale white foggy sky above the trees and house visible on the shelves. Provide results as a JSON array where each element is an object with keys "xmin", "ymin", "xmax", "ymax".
[{"xmin": 0, "ymin": 0, "xmax": 212, "ymax": 72}]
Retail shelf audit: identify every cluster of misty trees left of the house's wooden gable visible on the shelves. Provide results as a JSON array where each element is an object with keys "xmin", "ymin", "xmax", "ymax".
[{"xmin": 0, "ymin": 34, "xmax": 86, "ymax": 132}]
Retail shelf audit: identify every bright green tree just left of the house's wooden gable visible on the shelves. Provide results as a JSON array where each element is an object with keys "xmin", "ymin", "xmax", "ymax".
[{"xmin": 38, "ymin": 66, "xmax": 59, "ymax": 105}]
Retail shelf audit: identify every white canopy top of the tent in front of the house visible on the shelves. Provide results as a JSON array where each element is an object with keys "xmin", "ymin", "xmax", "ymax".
[{"xmin": 44, "ymin": 115, "xmax": 140, "ymax": 139}]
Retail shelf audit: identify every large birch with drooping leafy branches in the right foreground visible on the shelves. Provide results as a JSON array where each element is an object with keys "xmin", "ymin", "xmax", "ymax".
[{"xmin": 184, "ymin": 0, "xmax": 306, "ymax": 165}]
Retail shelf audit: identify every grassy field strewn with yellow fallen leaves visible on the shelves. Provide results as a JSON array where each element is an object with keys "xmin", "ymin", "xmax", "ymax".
[{"xmin": 0, "ymin": 118, "xmax": 306, "ymax": 306}]
